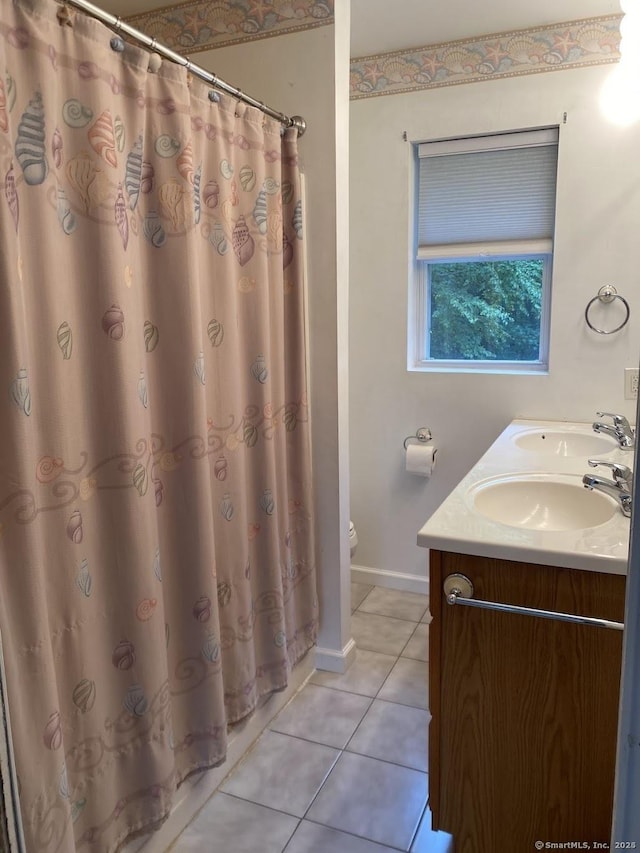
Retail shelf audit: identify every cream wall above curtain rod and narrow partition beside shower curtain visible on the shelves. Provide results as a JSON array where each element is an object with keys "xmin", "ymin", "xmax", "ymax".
[{"xmin": 196, "ymin": 20, "xmax": 355, "ymax": 671}]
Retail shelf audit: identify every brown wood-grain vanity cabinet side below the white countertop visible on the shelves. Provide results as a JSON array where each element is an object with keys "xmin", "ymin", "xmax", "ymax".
[{"xmin": 429, "ymin": 550, "xmax": 625, "ymax": 853}]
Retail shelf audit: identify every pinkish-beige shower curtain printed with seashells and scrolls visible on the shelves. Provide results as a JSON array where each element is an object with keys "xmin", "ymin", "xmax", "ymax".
[{"xmin": 0, "ymin": 0, "xmax": 317, "ymax": 853}]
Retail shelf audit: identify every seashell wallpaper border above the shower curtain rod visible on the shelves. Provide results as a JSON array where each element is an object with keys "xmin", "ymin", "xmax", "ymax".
[{"xmin": 127, "ymin": 0, "xmax": 334, "ymax": 53}]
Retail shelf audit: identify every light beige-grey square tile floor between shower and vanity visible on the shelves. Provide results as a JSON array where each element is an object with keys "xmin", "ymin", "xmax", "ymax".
[{"xmin": 171, "ymin": 584, "xmax": 452, "ymax": 853}]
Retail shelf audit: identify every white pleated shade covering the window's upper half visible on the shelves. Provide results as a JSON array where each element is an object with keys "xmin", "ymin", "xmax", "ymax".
[{"xmin": 418, "ymin": 128, "xmax": 558, "ymax": 251}]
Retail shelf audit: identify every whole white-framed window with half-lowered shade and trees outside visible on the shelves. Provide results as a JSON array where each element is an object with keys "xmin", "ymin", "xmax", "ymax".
[{"xmin": 409, "ymin": 128, "xmax": 558, "ymax": 372}]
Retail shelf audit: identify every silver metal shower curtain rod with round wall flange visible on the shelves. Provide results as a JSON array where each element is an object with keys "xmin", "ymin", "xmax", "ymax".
[{"xmin": 64, "ymin": 0, "xmax": 307, "ymax": 136}]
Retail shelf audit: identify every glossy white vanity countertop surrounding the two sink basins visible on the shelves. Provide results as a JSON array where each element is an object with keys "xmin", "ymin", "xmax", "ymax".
[{"xmin": 418, "ymin": 420, "xmax": 634, "ymax": 574}]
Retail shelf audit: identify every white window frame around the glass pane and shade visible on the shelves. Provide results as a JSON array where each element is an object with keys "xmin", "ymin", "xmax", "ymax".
[{"xmin": 407, "ymin": 125, "xmax": 560, "ymax": 375}]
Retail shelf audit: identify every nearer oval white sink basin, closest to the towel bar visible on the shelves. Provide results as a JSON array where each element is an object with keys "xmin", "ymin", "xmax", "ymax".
[{"xmin": 467, "ymin": 472, "xmax": 620, "ymax": 530}]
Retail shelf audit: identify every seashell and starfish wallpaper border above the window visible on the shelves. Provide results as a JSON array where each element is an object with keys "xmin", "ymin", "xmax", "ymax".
[{"xmin": 350, "ymin": 15, "xmax": 622, "ymax": 100}]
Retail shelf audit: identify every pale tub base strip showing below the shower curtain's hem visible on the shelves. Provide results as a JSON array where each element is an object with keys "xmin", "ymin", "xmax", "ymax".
[{"xmin": 131, "ymin": 650, "xmax": 315, "ymax": 853}]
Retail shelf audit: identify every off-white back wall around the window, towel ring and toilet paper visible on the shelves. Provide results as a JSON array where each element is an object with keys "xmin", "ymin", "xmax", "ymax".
[{"xmin": 350, "ymin": 65, "xmax": 640, "ymax": 589}]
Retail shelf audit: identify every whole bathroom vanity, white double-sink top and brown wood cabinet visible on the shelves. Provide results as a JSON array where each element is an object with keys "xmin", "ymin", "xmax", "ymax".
[{"xmin": 418, "ymin": 421, "xmax": 632, "ymax": 853}]
